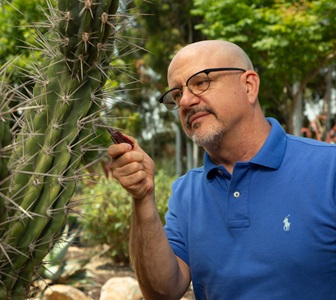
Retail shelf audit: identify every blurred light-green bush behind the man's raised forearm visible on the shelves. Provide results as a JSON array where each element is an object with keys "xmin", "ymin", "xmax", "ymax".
[{"xmin": 77, "ymin": 170, "xmax": 174, "ymax": 264}]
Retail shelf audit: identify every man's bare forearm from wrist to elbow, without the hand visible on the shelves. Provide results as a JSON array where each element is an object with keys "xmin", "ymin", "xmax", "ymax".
[{"xmin": 130, "ymin": 199, "xmax": 188, "ymax": 299}]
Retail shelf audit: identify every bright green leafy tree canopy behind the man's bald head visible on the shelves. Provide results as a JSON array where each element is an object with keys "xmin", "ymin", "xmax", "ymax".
[{"xmin": 192, "ymin": 0, "xmax": 336, "ymax": 131}]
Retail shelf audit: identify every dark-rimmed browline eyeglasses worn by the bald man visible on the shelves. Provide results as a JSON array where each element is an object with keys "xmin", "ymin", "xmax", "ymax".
[{"xmin": 159, "ymin": 68, "xmax": 246, "ymax": 110}]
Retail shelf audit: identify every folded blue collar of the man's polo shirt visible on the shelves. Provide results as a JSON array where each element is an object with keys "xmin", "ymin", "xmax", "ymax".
[{"xmin": 204, "ymin": 118, "xmax": 286, "ymax": 176}]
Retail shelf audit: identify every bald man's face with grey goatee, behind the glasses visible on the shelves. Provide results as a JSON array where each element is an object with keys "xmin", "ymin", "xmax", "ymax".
[{"xmin": 169, "ymin": 59, "xmax": 247, "ymax": 149}]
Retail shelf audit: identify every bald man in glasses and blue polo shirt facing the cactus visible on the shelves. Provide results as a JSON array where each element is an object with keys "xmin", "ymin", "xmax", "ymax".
[{"xmin": 108, "ymin": 41, "xmax": 336, "ymax": 300}]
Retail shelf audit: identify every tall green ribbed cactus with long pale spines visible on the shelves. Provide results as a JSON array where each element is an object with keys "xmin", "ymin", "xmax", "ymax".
[{"xmin": 0, "ymin": 0, "xmax": 124, "ymax": 299}]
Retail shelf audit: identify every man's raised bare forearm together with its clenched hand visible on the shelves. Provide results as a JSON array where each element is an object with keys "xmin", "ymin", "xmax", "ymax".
[{"xmin": 108, "ymin": 137, "xmax": 190, "ymax": 300}]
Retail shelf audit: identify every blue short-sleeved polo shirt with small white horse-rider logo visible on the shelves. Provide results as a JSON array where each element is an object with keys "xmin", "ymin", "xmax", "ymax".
[{"xmin": 165, "ymin": 118, "xmax": 336, "ymax": 300}]
